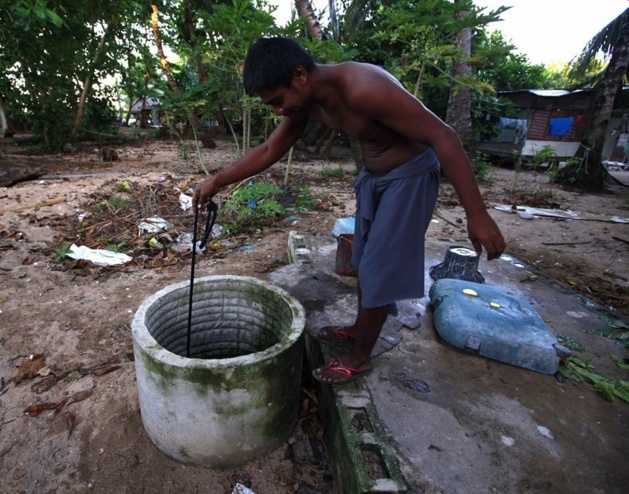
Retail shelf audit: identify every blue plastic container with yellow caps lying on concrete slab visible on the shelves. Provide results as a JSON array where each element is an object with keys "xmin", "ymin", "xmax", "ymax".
[{"xmin": 429, "ymin": 278, "xmax": 571, "ymax": 374}]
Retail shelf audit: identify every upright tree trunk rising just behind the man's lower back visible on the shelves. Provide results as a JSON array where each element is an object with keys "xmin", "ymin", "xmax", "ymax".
[{"xmin": 446, "ymin": 4, "xmax": 474, "ymax": 152}]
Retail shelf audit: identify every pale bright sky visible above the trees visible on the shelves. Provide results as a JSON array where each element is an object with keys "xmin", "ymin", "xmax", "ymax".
[{"xmin": 269, "ymin": 0, "xmax": 629, "ymax": 65}]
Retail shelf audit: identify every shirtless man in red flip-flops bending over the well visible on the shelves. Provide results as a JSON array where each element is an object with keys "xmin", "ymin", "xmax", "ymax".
[{"xmin": 193, "ymin": 38, "xmax": 505, "ymax": 384}]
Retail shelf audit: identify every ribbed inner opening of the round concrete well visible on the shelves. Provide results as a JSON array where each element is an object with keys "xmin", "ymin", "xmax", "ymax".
[{"xmin": 145, "ymin": 279, "xmax": 293, "ymax": 359}]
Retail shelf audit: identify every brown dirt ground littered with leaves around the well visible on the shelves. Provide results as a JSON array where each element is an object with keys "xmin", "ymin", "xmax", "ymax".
[{"xmin": 0, "ymin": 132, "xmax": 629, "ymax": 494}]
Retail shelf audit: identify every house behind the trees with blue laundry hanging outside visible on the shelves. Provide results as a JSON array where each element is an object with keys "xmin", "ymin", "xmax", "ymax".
[{"xmin": 478, "ymin": 89, "xmax": 629, "ymax": 164}]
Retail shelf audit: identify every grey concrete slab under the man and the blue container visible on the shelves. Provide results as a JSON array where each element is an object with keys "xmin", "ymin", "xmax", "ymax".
[{"xmin": 270, "ymin": 236, "xmax": 629, "ymax": 494}]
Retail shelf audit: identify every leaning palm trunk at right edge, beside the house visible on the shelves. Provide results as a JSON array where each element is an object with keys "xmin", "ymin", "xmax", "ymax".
[{"xmin": 557, "ymin": 15, "xmax": 629, "ymax": 192}]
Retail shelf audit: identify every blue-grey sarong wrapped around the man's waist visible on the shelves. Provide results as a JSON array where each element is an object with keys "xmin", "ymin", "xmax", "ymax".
[{"xmin": 352, "ymin": 149, "xmax": 439, "ymax": 307}]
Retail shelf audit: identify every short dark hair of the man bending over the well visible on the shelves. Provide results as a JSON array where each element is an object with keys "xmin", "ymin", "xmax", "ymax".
[{"xmin": 243, "ymin": 37, "xmax": 315, "ymax": 96}]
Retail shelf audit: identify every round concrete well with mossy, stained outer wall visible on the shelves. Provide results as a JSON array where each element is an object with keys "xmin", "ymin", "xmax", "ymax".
[{"xmin": 132, "ymin": 276, "xmax": 305, "ymax": 467}]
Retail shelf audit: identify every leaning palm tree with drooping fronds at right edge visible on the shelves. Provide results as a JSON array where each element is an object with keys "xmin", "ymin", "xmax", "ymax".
[{"xmin": 558, "ymin": 9, "xmax": 629, "ymax": 191}]
